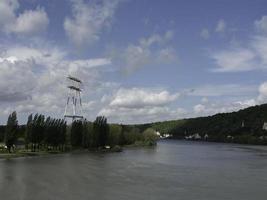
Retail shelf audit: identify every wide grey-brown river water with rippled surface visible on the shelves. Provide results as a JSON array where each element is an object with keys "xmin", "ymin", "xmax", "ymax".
[{"xmin": 0, "ymin": 140, "xmax": 267, "ymax": 200}]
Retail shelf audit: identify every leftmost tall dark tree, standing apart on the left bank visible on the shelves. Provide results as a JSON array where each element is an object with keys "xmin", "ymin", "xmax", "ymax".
[{"xmin": 5, "ymin": 111, "xmax": 18, "ymax": 153}]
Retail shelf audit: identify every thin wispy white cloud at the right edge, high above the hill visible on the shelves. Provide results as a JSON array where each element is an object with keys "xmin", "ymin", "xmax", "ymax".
[{"xmin": 211, "ymin": 16, "xmax": 267, "ymax": 72}]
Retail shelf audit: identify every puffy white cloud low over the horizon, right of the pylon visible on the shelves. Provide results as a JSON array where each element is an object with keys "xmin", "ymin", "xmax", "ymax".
[{"xmin": 98, "ymin": 88, "xmax": 187, "ymax": 123}]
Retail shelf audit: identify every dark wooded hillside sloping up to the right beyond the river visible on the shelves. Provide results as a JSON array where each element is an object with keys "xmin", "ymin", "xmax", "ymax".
[{"xmin": 139, "ymin": 104, "xmax": 267, "ymax": 145}]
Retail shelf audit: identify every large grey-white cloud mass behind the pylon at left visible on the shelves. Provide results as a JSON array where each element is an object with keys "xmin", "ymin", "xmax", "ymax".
[{"xmin": 0, "ymin": 46, "xmax": 115, "ymax": 122}]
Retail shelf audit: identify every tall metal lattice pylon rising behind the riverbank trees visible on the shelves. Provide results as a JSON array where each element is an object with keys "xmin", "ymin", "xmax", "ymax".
[{"xmin": 64, "ymin": 76, "xmax": 83, "ymax": 121}]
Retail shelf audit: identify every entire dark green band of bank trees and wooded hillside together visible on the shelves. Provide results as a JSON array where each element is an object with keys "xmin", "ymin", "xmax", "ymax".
[{"xmin": 0, "ymin": 104, "xmax": 267, "ymax": 152}]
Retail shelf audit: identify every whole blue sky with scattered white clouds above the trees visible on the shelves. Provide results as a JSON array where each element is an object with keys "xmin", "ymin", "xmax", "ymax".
[{"xmin": 0, "ymin": 0, "xmax": 267, "ymax": 124}]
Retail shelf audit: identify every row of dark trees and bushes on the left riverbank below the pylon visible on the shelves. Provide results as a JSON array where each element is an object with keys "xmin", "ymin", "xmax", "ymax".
[{"xmin": 0, "ymin": 112, "xmax": 157, "ymax": 158}]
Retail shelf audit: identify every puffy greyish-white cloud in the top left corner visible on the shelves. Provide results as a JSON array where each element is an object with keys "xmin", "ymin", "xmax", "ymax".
[{"xmin": 0, "ymin": 0, "xmax": 49, "ymax": 35}]
